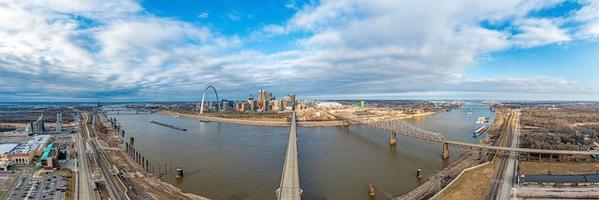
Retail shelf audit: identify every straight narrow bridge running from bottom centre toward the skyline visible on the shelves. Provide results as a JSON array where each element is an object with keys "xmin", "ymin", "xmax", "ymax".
[{"xmin": 276, "ymin": 112, "xmax": 302, "ymax": 200}]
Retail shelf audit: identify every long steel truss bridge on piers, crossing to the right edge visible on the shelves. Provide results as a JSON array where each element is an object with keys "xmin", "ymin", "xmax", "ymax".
[{"xmin": 331, "ymin": 112, "xmax": 599, "ymax": 159}]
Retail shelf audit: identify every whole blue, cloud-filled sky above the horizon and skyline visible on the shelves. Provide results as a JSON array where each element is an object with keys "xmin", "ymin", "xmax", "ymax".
[{"xmin": 0, "ymin": 0, "xmax": 599, "ymax": 102}]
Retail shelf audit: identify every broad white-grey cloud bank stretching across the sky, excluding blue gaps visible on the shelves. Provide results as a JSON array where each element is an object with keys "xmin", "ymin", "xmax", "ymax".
[{"xmin": 0, "ymin": 0, "xmax": 599, "ymax": 100}]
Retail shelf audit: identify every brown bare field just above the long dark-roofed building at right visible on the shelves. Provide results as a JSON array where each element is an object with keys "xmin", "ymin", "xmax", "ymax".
[{"xmin": 519, "ymin": 162, "xmax": 599, "ymax": 174}]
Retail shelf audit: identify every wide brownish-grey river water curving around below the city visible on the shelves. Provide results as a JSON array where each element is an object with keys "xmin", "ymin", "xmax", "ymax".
[{"xmin": 110, "ymin": 105, "xmax": 495, "ymax": 199}]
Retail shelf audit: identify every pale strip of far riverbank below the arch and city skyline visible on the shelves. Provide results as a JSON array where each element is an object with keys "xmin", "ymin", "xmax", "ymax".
[{"xmin": 159, "ymin": 111, "xmax": 347, "ymax": 127}]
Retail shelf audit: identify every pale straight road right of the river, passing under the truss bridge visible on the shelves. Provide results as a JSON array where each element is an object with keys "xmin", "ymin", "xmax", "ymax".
[{"xmin": 497, "ymin": 110, "xmax": 520, "ymax": 199}]
